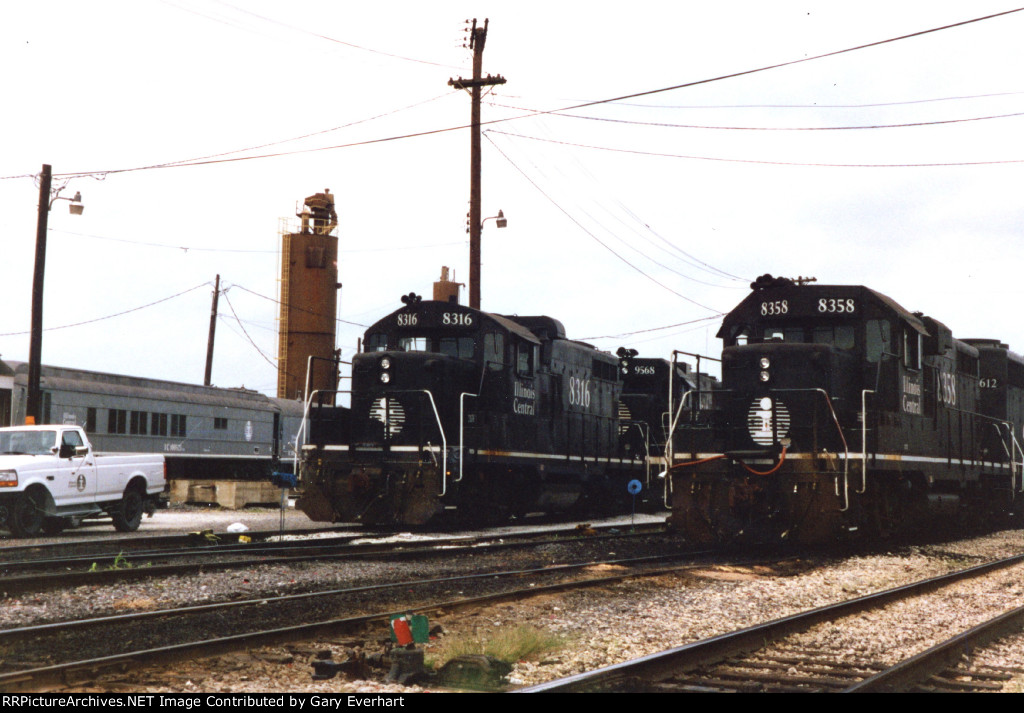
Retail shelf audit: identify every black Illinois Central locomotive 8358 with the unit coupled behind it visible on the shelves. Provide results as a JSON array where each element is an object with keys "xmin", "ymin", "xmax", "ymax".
[{"xmin": 670, "ymin": 276, "xmax": 1024, "ymax": 542}]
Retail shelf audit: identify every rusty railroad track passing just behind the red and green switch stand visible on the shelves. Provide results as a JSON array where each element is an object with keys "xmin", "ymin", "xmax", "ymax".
[{"xmin": 0, "ymin": 540, "xmax": 720, "ymax": 691}]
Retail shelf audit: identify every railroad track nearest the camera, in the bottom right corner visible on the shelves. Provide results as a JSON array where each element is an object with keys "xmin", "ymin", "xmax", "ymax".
[{"xmin": 517, "ymin": 555, "xmax": 1024, "ymax": 693}]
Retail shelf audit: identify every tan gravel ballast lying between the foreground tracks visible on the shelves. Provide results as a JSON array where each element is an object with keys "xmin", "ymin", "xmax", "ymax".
[{"xmin": 12, "ymin": 531, "xmax": 1024, "ymax": 693}]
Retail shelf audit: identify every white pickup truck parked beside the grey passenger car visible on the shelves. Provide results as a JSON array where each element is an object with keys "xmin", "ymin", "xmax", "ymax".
[{"xmin": 0, "ymin": 425, "xmax": 166, "ymax": 537}]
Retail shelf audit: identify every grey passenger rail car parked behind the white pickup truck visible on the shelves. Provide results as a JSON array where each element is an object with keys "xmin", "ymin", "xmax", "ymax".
[{"xmin": 5, "ymin": 364, "xmax": 302, "ymax": 479}]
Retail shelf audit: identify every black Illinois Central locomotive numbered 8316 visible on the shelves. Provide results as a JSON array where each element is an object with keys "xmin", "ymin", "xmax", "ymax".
[{"xmin": 297, "ymin": 295, "xmax": 679, "ymax": 527}]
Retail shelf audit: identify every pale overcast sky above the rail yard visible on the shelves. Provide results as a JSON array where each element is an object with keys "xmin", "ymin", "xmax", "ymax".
[{"xmin": 0, "ymin": 0, "xmax": 1024, "ymax": 394}]
